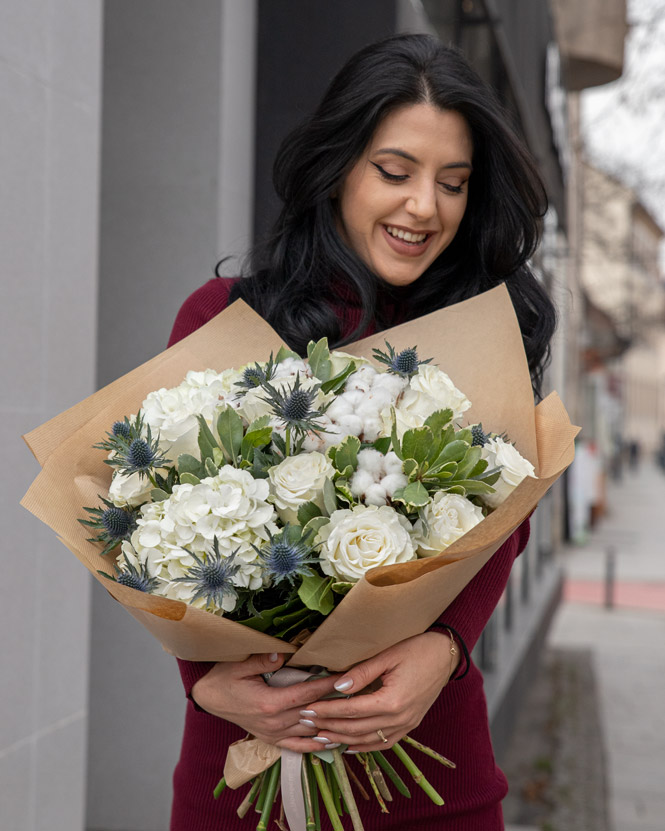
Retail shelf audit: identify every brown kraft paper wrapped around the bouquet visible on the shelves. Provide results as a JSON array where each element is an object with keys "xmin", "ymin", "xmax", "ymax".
[{"xmin": 21, "ymin": 286, "xmax": 579, "ymax": 670}]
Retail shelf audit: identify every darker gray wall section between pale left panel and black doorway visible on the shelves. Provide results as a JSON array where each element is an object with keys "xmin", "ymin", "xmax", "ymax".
[{"xmin": 87, "ymin": 0, "xmax": 255, "ymax": 831}]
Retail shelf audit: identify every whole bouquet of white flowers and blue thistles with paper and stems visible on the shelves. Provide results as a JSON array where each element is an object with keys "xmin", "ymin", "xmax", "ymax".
[{"xmin": 24, "ymin": 289, "xmax": 577, "ymax": 831}]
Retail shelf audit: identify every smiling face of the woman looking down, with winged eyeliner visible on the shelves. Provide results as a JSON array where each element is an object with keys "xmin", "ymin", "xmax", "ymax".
[{"xmin": 337, "ymin": 104, "xmax": 473, "ymax": 286}]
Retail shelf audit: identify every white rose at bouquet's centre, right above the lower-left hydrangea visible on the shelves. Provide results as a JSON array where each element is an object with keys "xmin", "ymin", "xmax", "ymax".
[{"xmin": 268, "ymin": 452, "xmax": 335, "ymax": 525}]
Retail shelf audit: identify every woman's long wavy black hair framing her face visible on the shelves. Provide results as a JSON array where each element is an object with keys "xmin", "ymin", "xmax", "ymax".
[{"xmin": 231, "ymin": 35, "xmax": 556, "ymax": 395}]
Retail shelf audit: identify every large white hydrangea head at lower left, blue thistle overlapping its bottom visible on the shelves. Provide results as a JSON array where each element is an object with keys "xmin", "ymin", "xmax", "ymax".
[{"xmin": 123, "ymin": 465, "xmax": 278, "ymax": 611}]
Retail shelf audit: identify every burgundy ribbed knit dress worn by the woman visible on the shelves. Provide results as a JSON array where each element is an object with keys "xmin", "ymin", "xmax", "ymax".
[{"xmin": 169, "ymin": 278, "xmax": 529, "ymax": 831}]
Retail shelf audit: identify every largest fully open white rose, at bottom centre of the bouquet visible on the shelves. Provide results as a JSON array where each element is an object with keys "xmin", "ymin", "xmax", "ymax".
[{"xmin": 317, "ymin": 505, "xmax": 416, "ymax": 583}]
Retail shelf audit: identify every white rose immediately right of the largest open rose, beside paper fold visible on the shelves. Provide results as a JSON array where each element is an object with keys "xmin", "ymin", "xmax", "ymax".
[{"xmin": 413, "ymin": 491, "xmax": 483, "ymax": 557}]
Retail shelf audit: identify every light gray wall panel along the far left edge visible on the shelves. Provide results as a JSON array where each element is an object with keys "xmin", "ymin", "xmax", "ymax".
[{"xmin": 0, "ymin": 0, "xmax": 101, "ymax": 831}]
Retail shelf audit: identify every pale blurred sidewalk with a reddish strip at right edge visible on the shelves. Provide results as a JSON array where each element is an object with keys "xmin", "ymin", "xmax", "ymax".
[{"xmin": 548, "ymin": 463, "xmax": 665, "ymax": 831}]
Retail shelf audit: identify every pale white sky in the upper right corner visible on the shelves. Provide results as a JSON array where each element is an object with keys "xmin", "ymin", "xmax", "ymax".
[{"xmin": 582, "ymin": 0, "xmax": 665, "ymax": 250}]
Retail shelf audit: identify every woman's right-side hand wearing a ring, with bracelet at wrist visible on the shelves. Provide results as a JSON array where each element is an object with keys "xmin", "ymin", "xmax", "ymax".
[{"xmin": 301, "ymin": 632, "xmax": 459, "ymax": 752}]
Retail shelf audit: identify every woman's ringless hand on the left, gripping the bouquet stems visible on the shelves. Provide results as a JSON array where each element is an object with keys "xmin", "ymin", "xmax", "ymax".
[{"xmin": 187, "ymin": 653, "xmax": 340, "ymax": 753}]
